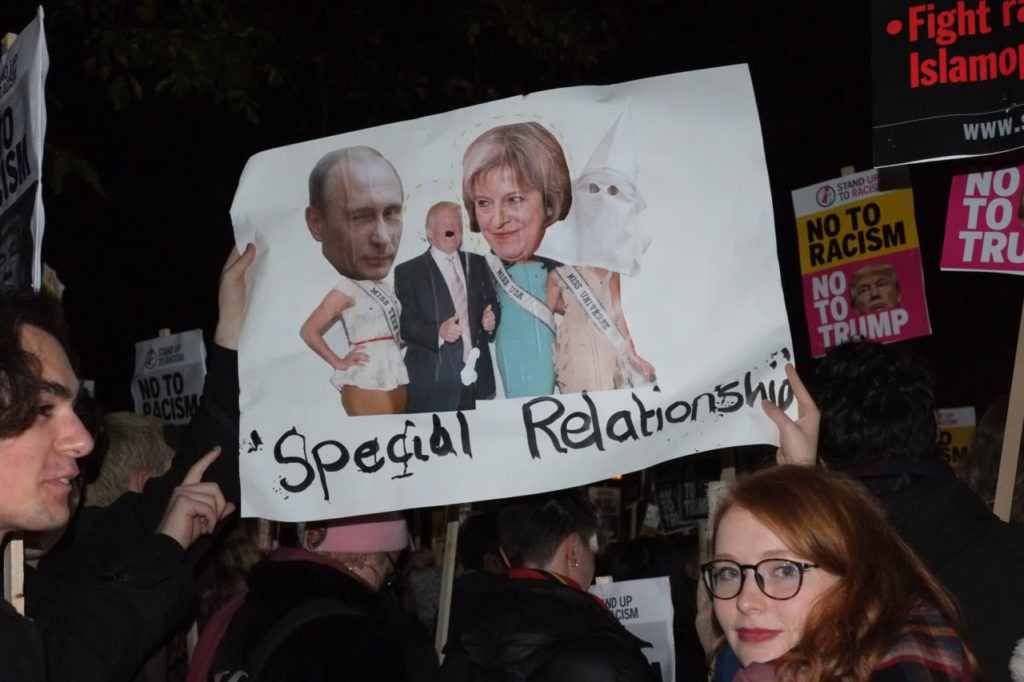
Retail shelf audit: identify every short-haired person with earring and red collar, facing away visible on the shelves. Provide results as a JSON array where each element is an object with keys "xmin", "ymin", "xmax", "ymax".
[{"xmin": 438, "ymin": 492, "xmax": 657, "ymax": 682}]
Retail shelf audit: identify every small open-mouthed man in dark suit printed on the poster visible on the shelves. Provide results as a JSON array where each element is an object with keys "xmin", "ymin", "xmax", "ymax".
[{"xmin": 394, "ymin": 202, "xmax": 500, "ymax": 413}]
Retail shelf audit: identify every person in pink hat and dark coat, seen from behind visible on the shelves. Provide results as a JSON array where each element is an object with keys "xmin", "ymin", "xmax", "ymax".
[{"xmin": 193, "ymin": 513, "xmax": 437, "ymax": 682}]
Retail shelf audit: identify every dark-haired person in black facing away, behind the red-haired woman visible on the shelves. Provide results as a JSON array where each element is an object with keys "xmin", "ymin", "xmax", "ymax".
[{"xmin": 811, "ymin": 341, "xmax": 1024, "ymax": 682}]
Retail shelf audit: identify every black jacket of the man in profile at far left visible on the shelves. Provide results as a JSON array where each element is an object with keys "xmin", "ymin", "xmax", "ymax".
[{"xmin": 25, "ymin": 346, "xmax": 240, "ymax": 682}]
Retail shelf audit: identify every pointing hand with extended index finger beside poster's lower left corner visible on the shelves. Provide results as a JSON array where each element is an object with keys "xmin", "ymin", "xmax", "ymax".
[{"xmin": 157, "ymin": 447, "xmax": 234, "ymax": 549}]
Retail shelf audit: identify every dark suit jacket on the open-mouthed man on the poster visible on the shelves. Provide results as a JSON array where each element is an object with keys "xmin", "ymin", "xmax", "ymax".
[{"xmin": 394, "ymin": 249, "xmax": 501, "ymax": 413}]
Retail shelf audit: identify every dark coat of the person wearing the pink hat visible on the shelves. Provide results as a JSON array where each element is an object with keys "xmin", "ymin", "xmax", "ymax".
[{"xmin": 208, "ymin": 549, "xmax": 437, "ymax": 682}]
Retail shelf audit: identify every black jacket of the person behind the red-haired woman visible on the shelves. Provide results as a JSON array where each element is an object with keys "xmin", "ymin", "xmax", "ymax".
[{"xmin": 854, "ymin": 458, "xmax": 1024, "ymax": 682}]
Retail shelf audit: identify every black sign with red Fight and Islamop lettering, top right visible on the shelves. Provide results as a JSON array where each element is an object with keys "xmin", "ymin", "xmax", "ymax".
[{"xmin": 871, "ymin": 0, "xmax": 1024, "ymax": 167}]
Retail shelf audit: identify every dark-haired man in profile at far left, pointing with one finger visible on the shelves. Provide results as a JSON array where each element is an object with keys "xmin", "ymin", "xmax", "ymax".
[{"xmin": 0, "ymin": 259, "xmax": 234, "ymax": 680}]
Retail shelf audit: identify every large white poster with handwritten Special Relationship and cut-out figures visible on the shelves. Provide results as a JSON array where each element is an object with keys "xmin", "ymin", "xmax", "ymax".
[{"xmin": 231, "ymin": 66, "xmax": 793, "ymax": 520}]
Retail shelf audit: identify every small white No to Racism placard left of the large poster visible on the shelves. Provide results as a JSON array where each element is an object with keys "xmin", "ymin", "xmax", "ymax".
[{"xmin": 131, "ymin": 329, "xmax": 206, "ymax": 424}]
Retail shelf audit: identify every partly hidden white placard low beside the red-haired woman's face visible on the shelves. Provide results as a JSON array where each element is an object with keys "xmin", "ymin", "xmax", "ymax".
[{"xmin": 590, "ymin": 577, "xmax": 676, "ymax": 682}]
